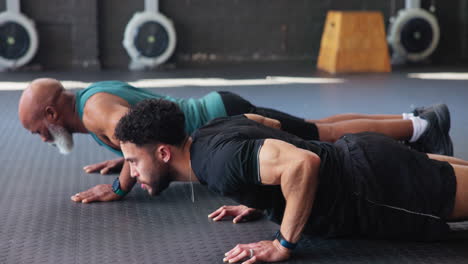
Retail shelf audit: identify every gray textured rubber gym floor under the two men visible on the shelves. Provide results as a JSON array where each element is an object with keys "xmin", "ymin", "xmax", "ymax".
[{"xmin": 0, "ymin": 64, "xmax": 468, "ymax": 263}]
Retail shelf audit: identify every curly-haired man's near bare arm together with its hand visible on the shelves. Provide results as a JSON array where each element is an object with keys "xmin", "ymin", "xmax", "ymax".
[{"xmin": 223, "ymin": 139, "xmax": 320, "ymax": 264}]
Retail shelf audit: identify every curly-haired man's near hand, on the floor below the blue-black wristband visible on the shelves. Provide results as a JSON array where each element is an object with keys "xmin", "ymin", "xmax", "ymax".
[{"xmin": 223, "ymin": 239, "xmax": 291, "ymax": 264}]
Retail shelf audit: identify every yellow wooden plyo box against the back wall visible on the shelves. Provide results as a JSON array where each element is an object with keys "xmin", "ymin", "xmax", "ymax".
[{"xmin": 317, "ymin": 11, "xmax": 391, "ymax": 73}]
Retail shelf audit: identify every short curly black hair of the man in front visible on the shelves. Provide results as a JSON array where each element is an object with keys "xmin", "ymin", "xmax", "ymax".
[{"xmin": 114, "ymin": 99, "xmax": 187, "ymax": 147}]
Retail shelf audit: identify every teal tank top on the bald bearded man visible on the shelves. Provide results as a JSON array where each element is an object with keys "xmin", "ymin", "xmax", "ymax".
[{"xmin": 75, "ymin": 81, "xmax": 227, "ymax": 156}]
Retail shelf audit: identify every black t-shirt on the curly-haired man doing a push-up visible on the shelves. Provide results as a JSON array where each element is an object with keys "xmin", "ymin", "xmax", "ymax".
[{"xmin": 190, "ymin": 115, "xmax": 341, "ymax": 233}]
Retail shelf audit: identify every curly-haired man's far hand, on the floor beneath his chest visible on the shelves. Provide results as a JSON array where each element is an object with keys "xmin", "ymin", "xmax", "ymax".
[{"xmin": 208, "ymin": 205, "xmax": 263, "ymax": 224}]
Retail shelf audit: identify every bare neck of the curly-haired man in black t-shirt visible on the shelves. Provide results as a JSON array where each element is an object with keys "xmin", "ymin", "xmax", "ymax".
[{"xmin": 172, "ymin": 137, "xmax": 198, "ymax": 182}]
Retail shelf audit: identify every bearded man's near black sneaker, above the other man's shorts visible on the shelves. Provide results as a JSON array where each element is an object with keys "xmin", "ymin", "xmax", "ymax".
[{"xmin": 410, "ymin": 104, "xmax": 453, "ymax": 156}]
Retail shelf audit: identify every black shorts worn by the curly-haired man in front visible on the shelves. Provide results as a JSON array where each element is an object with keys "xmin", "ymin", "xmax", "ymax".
[{"xmin": 319, "ymin": 132, "xmax": 456, "ymax": 241}]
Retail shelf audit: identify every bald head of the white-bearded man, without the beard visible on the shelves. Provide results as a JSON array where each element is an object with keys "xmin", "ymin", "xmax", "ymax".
[{"xmin": 18, "ymin": 78, "xmax": 65, "ymax": 128}]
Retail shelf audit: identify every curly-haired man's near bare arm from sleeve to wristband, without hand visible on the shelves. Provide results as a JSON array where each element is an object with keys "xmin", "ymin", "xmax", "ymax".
[{"xmin": 259, "ymin": 139, "xmax": 320, "ymax": 243}]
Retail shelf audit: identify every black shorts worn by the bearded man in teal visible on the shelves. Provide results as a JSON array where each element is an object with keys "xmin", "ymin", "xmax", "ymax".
[{"xmin": 218, "ymin": 91, "xmax": 319, "ymax": 140}]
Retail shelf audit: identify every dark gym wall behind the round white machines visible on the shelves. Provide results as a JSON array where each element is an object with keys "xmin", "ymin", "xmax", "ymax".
[{"xmin": 0, "ymin": 0, "xmax": 468, "ymax": 70}]
